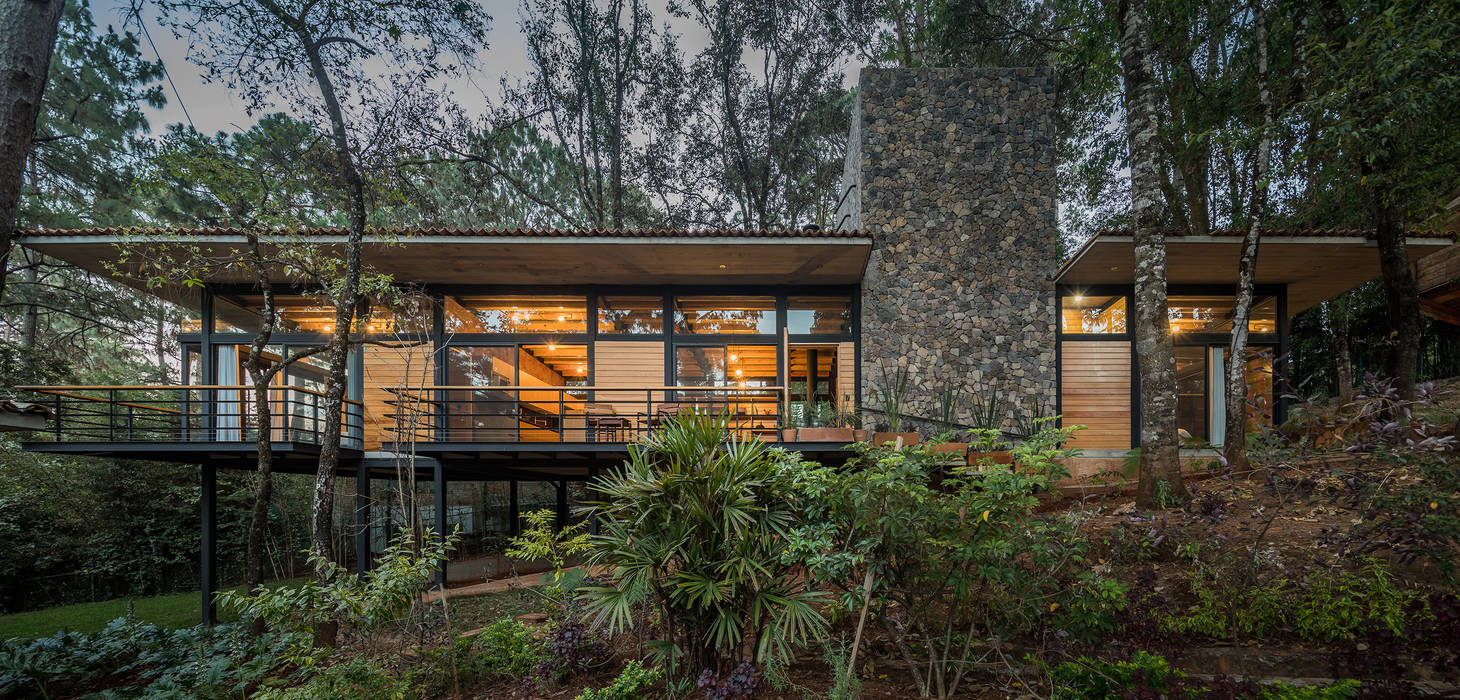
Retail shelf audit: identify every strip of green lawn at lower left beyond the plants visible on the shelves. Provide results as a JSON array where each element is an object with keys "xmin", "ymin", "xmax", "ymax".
[{"xmin": 0, "ymin": 582, "xmax": 300, "ymax": 639}]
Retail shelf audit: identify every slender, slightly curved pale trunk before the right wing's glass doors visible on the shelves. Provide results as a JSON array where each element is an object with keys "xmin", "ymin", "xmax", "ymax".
[{"xmin": 1222, "ymin": 0, "xmax": 1275, "ymax": 473}]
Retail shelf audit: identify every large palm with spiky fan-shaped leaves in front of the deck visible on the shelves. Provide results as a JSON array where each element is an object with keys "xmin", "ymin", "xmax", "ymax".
[{"xmin": 584, "ymin": 415, "xmax": 826, "ymax": 684}]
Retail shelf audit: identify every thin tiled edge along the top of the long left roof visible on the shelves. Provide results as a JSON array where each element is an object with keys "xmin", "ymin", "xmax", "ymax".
[{"xmin": 20, "ymin": 227, "xmax": 872, "ymax": 240}]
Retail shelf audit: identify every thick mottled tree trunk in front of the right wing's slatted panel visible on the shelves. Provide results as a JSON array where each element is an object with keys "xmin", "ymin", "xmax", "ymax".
[{"xmin": 1117, "ymin": 0, "xmax": 1186, "ymax": 509}]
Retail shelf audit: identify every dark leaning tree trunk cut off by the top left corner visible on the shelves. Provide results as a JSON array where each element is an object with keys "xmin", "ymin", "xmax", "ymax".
[{"xmin": 0, "ymin": 0, "xmax": 66, "ymax": 301}]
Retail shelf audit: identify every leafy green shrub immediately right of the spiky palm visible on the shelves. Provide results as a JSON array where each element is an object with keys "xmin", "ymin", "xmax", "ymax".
[{"xmin": 787, "ymin": 421, "xmax": 1124, "ymax": 697}]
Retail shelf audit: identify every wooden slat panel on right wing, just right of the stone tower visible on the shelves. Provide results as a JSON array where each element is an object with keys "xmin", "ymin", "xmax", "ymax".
[{"xmin": 1060, "ymin": 341, "xmax": 1130, "ymax": 450}]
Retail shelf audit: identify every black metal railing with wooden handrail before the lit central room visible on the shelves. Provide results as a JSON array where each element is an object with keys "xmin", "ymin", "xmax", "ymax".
[{"xmin": 385, "ymin": 386, "xmax": 785, "ymax": 443}]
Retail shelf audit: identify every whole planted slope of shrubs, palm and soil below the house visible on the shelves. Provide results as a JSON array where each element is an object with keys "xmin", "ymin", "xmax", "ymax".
[{"xmin": 0, "ymin": 406, "xmax": 1460, "ymax": 699}]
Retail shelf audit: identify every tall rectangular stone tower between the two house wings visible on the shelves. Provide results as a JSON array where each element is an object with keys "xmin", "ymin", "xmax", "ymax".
[{"xmin": 835, "ymin": 69, "xmax": 1059, "ymax": 430}]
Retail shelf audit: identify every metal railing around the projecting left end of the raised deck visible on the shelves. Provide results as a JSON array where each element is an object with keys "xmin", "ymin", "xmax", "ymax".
[{"xmin": 16, "ymin": 384, "xmax": 364, "ymax": 449}]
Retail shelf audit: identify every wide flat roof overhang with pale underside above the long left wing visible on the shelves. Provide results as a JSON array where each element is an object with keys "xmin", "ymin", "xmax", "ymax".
[{"xmin": 20, "ymin": 231, "xmax": 872, "ymax": 285}]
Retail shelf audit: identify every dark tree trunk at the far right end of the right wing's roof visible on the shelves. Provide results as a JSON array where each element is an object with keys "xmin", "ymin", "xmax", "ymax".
[{"xmin": 1371, "ymin": 187, "xmax": 1419, "ymax": 399}]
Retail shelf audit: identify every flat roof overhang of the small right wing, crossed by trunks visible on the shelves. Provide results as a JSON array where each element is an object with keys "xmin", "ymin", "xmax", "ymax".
[{"xmin": 1054, "ymin": 234, "xmax": 1453, "ymax": 314}]
